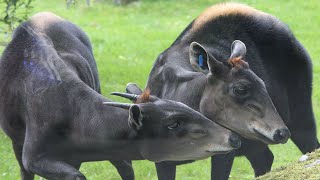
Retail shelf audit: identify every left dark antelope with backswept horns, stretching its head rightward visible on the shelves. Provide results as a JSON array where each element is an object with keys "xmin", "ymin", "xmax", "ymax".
[{"xmin": 0, "ymin": 13, "xmax": 240, "ymax": 180}]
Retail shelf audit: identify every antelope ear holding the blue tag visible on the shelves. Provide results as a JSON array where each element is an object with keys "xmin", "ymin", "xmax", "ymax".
[{"xmin": 189, "ymin": 42, "xmax": 224, "ymax": 75}]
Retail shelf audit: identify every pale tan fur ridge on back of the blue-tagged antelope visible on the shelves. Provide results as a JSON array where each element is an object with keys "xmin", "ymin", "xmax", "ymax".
[{"xmin": 192, "ymin": 3, "xmax": 268, "ymax": 31}]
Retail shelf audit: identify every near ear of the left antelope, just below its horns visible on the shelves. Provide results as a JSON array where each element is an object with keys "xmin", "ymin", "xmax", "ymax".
[{"xmin": 128, "ymin": 104, "xmax": 143, "ymax": 132}]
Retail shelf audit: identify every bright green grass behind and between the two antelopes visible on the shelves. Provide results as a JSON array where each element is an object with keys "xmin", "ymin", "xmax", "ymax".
[{"xmin": 0, "ymin": 0, "xmax": 320, "ymax": 180}]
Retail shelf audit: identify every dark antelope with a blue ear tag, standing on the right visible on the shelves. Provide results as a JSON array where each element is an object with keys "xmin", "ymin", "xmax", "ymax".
[{"xmin": 122, "ymin": 3, "xmax": 319, "ymax": 180}]
